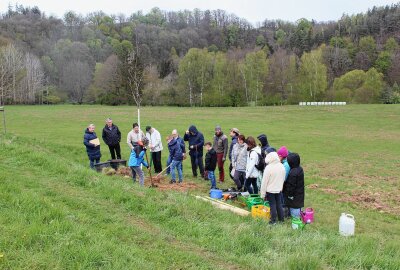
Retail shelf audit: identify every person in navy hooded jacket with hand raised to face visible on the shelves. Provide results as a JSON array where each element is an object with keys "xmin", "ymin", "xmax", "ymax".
[{"xmin": 183, "ymin": 125, "xmax": 207, "ymax": 180}]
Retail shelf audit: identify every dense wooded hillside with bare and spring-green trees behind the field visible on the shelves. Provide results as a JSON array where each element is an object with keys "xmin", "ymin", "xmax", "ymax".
[{"xmin": 0, "ymin": 4, "xmax": 400, "ymax": 106}]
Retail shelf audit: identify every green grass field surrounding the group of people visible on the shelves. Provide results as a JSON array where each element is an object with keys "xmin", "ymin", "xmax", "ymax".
[{"xmin": 0, "ymin": 105, "xmax": 400, "ymax": 269}]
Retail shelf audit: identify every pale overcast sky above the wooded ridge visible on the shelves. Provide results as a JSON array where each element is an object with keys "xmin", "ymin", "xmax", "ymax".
[{"xmin": 0, "ymin": 0, "xmax": 399, "ymax": 25}]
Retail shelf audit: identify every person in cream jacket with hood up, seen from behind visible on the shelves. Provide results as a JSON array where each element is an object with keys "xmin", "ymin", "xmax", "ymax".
[{"xmin": 261, "ymin": 152, "xmax": 286, "ymax": 224}]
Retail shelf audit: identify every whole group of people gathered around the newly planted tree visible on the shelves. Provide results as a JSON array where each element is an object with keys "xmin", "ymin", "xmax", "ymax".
[{"xmin": 84, "ymin": 118, "xmax": 304, "ymax": 224}]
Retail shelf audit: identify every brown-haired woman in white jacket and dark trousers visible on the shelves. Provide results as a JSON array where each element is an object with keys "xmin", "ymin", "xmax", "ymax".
[{"xmin": 245, "ymin": 136, "xmax": 261, "ymax": 194}]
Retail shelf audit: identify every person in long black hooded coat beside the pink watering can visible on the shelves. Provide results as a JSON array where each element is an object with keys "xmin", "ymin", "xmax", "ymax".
[{"xmin": 283, "ymin": 153, "xmax": 304, "ymax": 217}]
